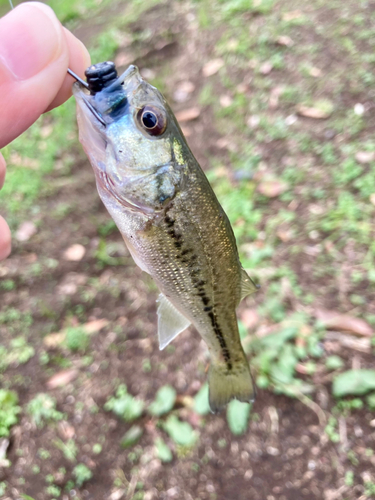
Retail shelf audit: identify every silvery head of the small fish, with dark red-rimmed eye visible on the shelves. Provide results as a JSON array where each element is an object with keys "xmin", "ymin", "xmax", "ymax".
[{"xmin": 73, "ymin": 63, "xmax": 188, "ymax": 211}]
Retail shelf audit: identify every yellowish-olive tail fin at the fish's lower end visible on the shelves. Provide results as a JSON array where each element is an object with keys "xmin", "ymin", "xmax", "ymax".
[{"xmin": 208, "ymin": 356, "xmax": 255, "ymax": 413}]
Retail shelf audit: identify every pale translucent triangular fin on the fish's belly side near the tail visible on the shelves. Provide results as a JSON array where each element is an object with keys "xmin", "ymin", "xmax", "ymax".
[{"xmin": 158, "ymin": 293, "xmax": 190, "ymax": 350}]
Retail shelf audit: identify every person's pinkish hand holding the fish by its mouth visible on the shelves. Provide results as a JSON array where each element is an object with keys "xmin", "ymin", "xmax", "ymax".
[{"xmin": 0, "ymin": 2, "xmax": 90, "ymax": 260}]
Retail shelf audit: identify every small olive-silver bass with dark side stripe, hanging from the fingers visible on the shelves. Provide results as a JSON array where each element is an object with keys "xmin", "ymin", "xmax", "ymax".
[{"xmin": 73, "ymin": 61, "xmax": 257, "ymax": 412}]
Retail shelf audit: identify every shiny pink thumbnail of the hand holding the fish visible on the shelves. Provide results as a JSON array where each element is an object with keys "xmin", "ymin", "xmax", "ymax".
[{"xmin": 0, "ymin": 2, "xmax": 62, "ymax": 80}]
